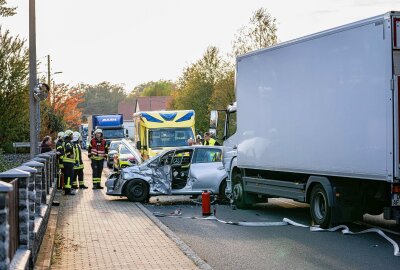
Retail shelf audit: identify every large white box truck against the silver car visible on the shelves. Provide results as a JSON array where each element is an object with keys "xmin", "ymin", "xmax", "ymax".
[{"xmin": 211, "ymin": 12, "xmax": 400, "ymax": 227}]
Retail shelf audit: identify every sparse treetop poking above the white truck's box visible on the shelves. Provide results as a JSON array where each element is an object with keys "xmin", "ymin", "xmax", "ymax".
[{"xmin": 233, "ymin": 8, "xmax": 278, "ymax": 56}]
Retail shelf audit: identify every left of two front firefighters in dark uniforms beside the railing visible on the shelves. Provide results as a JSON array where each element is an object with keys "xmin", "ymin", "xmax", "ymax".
[{"xmin": 63, "ymin": 130, "xmax": 76, "ymax": 195}]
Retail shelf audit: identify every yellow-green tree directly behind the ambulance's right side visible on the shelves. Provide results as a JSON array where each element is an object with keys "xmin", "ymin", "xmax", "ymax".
[{"xmin": 170, "ymin": 47, "xmax": 227, "ymax": 132}]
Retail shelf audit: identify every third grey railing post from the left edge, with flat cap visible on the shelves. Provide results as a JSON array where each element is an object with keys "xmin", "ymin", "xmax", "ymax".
[{"xmin": 16, "ymin": 166, "xmax": 38, "ymax": 250}]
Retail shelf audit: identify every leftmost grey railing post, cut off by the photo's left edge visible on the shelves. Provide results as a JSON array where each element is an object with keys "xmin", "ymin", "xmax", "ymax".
[{"xmin": 0, "ymin": 181, "xmax": 12, "ymax": 270}]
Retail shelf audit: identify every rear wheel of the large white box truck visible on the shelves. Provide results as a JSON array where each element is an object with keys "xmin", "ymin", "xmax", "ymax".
[{"xmin": 310, "ymin": 184, "xmax": 331, "ymax": 228}]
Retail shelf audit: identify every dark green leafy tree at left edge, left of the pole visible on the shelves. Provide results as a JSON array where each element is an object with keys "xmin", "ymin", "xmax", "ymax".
[{"xmin": 0, "ymin": 28, "xmax": 29, "ymax": 152}]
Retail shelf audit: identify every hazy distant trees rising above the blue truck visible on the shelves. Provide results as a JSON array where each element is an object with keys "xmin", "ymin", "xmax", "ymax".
[{"xmin": 78, "ymin": 82, "xmax": 126, "ymax": 115}]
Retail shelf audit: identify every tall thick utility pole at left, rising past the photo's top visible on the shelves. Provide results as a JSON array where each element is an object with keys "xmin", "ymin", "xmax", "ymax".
[{"xmin": 29, "ymin": 0, "xmax": 40, "ymax": 158}]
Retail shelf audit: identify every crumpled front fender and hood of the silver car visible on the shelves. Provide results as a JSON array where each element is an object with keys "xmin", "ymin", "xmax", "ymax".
[{"xmin": 121, "ymin": 166, "xmax": 172, "ymax": 195}]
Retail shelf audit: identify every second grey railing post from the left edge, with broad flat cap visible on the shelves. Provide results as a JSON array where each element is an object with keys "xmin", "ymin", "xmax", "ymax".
[{"xmin": 0, "ymin": 169, "xmax": 31, "ymax": 248}]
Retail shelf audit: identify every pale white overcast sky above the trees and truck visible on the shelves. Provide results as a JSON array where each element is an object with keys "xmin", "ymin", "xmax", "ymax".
[{"xmin": 0, "ymin": 0, "xmax": 400, "ymax": 92}]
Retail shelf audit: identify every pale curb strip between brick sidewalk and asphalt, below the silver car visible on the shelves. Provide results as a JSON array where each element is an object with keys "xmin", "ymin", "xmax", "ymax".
[{"xmin": 135, "ymin": 203, "xmax": 212, "ymax": 270}]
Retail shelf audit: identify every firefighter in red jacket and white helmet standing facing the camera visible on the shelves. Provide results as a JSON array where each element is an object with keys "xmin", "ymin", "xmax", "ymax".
[{"xmin": 88, "ymin": 129, "xmax": 108, "ymax": 189}]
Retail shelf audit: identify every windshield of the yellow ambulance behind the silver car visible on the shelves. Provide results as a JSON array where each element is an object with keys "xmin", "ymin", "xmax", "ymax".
[{"xmin": 149, "ymin": 127, "xmax": 194, "ymax": 148}]
